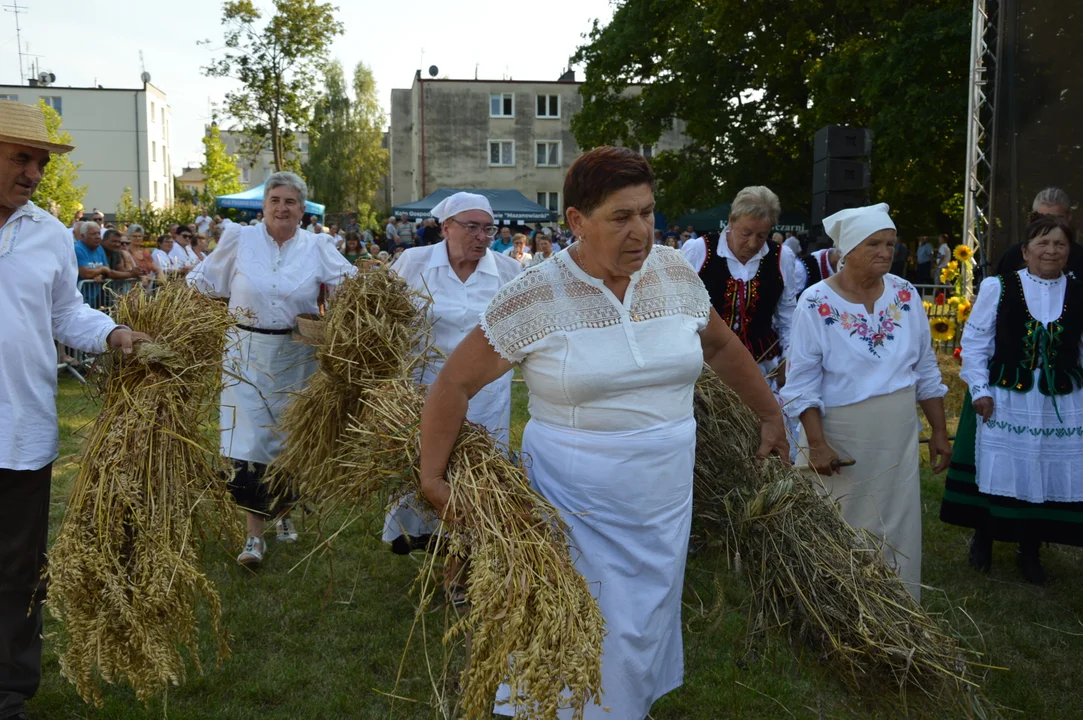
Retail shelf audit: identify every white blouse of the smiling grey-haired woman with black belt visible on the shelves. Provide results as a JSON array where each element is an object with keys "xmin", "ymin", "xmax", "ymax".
[{"xmin": 187, "ymin": 223, "xmax": 357, "ymax": 330}]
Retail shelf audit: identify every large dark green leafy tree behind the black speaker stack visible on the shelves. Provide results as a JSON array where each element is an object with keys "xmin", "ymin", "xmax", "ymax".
[{"xmin": 572, "ymin": 0, "xmax": 970, "ymax": 228}]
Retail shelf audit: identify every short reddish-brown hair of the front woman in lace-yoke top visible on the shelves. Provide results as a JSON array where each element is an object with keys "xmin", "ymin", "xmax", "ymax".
[{"xmin": 564, "ymin": 145, "xmax": 654, "ymax": 220}]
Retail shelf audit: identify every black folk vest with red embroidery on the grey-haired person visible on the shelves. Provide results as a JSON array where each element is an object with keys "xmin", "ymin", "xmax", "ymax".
[{"xmin": 700, "ymin": 233, "xmax": 784, "ymax": 363}]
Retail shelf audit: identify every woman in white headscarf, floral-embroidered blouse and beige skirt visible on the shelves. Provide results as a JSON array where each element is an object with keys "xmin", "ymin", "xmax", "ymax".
[{"xmin": 782, "ymin": 204, "xmax": 951, "ymax": 599}]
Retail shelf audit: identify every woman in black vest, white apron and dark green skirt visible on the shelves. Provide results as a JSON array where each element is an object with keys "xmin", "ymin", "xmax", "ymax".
[{"xmin": 940, "ymin": 215, "xmax": 1083, "ymax": 585}]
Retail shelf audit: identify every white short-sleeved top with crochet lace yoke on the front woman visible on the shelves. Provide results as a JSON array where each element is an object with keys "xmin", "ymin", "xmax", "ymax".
[{"xmin": 482, "ymin": 246, "xmax": 710, "ymax": 432}]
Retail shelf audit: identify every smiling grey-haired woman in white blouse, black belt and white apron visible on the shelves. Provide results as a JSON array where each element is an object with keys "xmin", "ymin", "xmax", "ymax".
[{"xmin": 187, "ymin": 172, "xmax": 357, "ymax": 566}]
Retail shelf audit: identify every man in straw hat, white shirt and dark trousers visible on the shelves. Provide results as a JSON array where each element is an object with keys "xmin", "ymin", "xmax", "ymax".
[{"xmin": 0, "ymin": 101, "xmax": 146, "ymax": 720}]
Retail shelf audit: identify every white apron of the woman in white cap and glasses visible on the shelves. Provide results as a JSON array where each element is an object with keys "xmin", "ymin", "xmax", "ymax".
[{"xmin": 382, "ymin": 370, "xmax": 512, "ymax": 542}]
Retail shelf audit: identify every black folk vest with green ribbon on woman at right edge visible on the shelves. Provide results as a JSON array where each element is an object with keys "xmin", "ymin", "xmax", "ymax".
[{"xmin": 989, "ymin": 273, "xmax": 1083, "ymax": 395}]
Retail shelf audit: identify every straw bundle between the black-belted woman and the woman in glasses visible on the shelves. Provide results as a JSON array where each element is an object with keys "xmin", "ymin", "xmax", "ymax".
[{"xmin": 269, "ymin": 267, "xmax": 431, "ymax": 512}]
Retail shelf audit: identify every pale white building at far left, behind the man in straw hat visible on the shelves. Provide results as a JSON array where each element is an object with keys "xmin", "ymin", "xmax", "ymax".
[{"xmin": 0, "ymin": 73, "xmax": 173, "ymax": 216}]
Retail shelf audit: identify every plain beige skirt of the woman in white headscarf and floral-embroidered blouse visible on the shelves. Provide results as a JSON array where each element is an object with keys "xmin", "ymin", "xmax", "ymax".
[{"xmin": 797, "ymin": 388, "xmax": 922, "ymax": 600}]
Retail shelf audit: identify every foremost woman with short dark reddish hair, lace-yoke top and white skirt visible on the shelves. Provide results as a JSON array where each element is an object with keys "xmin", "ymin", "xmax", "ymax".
[{"xmin": 421, "ymin": 147, "xmax": 790, "ymax": 720}]
